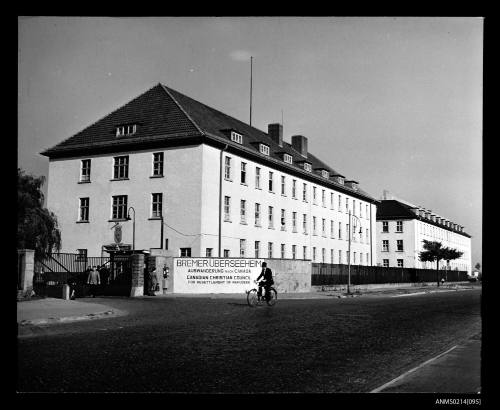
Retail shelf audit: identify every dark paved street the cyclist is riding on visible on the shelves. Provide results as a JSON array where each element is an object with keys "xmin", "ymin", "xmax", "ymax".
[{"xmin": 18, "ymin": 290, "xmax": 481, "ymax": 393}]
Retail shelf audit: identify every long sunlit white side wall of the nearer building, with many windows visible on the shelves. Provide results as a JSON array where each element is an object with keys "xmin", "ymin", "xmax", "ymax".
[{"xmin": 197, "ymin": 146, "xmax": 376, "ymax": 264}]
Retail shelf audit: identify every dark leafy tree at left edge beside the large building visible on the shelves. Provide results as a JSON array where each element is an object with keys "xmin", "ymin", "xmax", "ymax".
[{"xmin": 17, "ymin": 168, "xmax": 61, "ymax": 259}]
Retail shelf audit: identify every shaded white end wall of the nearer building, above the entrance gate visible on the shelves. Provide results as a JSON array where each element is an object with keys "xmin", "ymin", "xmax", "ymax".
[{"xmin": 47, "ymin": 146, "xmax": 202, "ymax": 256}]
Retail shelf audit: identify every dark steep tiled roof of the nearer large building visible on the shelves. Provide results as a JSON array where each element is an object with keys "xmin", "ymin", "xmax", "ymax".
[{"xmin": 42, "ymin": 84, "xmax": 377, "ymax": 202}]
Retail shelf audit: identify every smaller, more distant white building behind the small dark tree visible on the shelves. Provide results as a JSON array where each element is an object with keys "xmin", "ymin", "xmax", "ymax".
[{"xmin": 377, "ymin": 191, "xmax": 471, "ymax": 273}]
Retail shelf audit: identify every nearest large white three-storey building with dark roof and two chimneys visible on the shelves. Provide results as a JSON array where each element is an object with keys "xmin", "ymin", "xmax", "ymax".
[{"xmin": 42, "ymin": 84, "xmax": 378, "ymax": 265}]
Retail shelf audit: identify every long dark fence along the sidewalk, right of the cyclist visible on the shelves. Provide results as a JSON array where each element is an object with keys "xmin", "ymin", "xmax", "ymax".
[{"xmin": 311, "ymin": 263, "xmax": 467, "ymax": 286}]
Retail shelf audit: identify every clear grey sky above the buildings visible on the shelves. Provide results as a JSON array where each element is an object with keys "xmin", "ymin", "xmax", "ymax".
[{"xmin": 17, "ymin": 17, "xmax": 483, "ymax": 265}]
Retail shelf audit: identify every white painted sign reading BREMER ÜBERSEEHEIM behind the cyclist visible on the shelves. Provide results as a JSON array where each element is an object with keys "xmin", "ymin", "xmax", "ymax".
[{"xmin": 173, "ymin": 258, "xmax": 264, "ymax": 293}]
